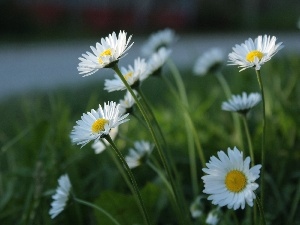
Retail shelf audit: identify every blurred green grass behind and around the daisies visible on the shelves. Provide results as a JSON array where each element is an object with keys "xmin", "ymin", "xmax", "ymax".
[{"xmin": 0, "ymin": 55, "xmax": 300, "ymax": 225}]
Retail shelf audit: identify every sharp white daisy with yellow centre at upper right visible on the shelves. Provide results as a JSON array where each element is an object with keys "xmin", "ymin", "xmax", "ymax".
[{"xmin": 228, "ymin": 35, "xmax": 283, "ymax": 71}]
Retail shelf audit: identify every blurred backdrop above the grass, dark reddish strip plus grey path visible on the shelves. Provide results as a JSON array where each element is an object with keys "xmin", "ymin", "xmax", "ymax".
[{"xmin": 0, "ymin": 0, "xmax": 300, "ymax": 100}]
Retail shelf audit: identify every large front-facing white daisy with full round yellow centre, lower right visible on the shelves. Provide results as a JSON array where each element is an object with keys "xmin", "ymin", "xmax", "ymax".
[{"xmin": 202, "ymin": 147, "xmax": 261, "ymax": 210}]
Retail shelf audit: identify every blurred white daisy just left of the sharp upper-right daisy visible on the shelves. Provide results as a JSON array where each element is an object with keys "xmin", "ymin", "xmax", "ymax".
[{"xmin": 194, "ymin": 48, "xmax": 225, "ymax": 76}]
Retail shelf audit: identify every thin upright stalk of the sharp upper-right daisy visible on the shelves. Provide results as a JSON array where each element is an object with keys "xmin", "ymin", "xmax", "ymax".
[{"xmin": 255, "ymin": 70, "xmax": 266, "ymax": 205}]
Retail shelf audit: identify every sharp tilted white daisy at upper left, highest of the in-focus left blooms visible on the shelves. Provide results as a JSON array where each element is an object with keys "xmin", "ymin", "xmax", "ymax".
[{"xmin": 77, "ymin": 31, "xmax": 133, "ymax": 77}]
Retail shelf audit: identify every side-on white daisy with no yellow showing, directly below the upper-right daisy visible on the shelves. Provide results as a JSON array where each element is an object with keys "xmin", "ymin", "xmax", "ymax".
[{"xmin": 221, "ymin": 92, "xmax": 261, "ymax": 114}]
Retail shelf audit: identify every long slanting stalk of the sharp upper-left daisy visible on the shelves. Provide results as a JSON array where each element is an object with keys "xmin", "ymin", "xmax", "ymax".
[{"xmin": 112, "ymin": 64, "xmax": 189, "ymax": 224}]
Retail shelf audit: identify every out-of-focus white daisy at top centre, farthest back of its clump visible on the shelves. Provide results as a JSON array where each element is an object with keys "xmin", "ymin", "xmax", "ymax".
[{"xmin": 141, "ymin": 28, "xmax": 177, "ymax": 56}]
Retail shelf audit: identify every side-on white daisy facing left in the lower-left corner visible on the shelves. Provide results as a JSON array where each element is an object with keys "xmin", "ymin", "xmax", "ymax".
[{"xmin": 49, "ymin": 174, "xmax": 72, "ymax": 219}]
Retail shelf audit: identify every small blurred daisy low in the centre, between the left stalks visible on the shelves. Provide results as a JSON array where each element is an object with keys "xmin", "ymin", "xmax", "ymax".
[{"xmin": 125, "ymin": 141, "xmax": 154, "ymax": 169}]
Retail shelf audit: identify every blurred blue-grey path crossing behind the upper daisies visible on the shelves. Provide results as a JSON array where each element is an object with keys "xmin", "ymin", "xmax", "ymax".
[{"xmin": 0, "ymin": 32, "xmax": 300, "ymax": 101}]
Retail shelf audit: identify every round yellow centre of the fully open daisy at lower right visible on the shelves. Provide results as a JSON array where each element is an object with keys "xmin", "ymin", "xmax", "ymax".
[{"xmin": 225, "ymin": 170, "xmax": 247, "ymax": 193}]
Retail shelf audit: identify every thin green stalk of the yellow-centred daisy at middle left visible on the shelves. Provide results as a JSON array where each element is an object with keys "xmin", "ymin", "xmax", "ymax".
[{"xmin": 104, "ymin": 135, "xmax": 151, "ymax": 225}]
